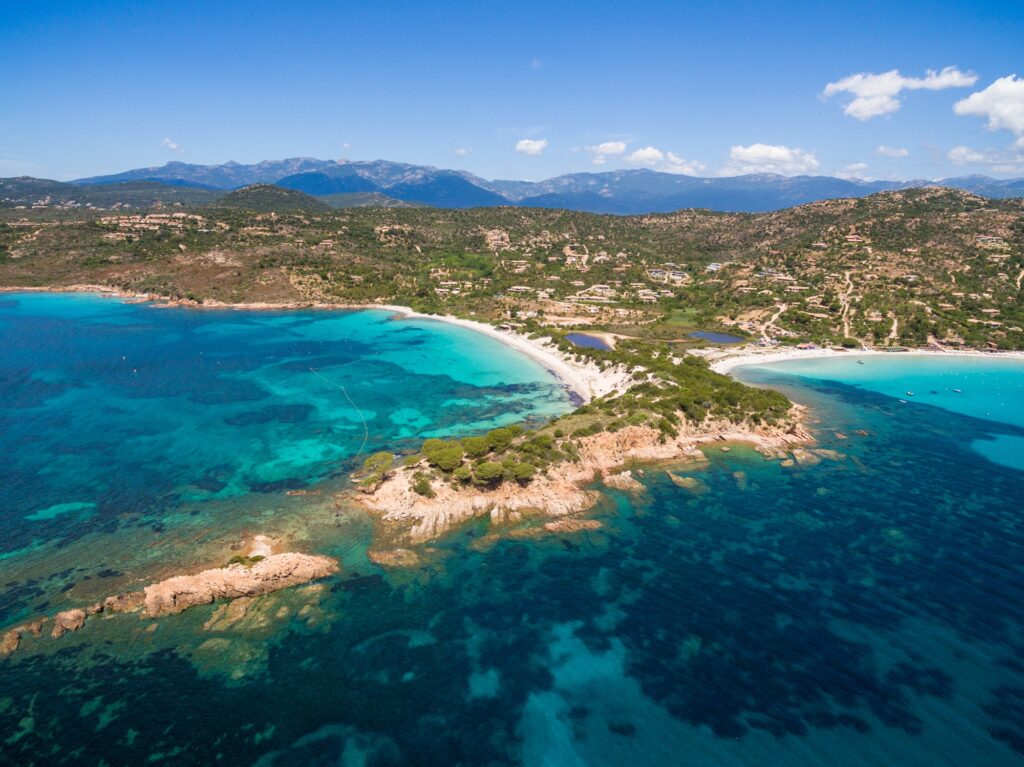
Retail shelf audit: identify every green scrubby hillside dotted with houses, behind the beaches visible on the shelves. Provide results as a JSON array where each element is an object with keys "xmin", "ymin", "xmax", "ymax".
[{"xmin": 0, "ymin": 186, "xmax": 1024, "ymax": 349}]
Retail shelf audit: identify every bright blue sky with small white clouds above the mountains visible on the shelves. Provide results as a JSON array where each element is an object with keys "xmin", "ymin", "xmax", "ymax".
[{"xmin": 0, "ymin": 0, "xmax": 1024, "ymax": 179}]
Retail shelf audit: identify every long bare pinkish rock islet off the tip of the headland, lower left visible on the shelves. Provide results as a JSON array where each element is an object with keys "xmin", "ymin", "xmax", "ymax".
[{"xmin": 143, "ymin": 553, "xmax": 338, "ymax": 617}]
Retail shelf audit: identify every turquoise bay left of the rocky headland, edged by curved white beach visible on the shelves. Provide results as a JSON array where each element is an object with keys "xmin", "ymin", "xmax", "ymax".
[{"xmin": 0, "ymin": 294, "xmax": 571, "ymax": 624}]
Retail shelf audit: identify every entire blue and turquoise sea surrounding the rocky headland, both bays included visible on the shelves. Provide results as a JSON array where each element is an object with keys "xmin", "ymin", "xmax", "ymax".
[{"xmin": 0, "ymin": 295, "xmax": 1024, "ymax": 767}]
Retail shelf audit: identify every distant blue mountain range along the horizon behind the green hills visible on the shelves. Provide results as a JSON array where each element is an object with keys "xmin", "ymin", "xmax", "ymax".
[{"xmin": 0, "ymin": 158, "xmax": 1024, "ymax": 214}]
